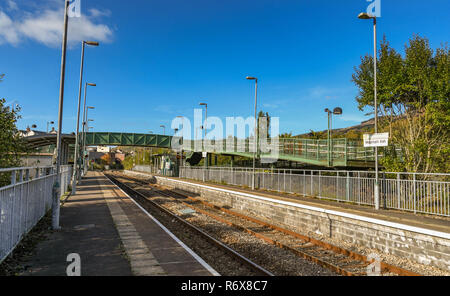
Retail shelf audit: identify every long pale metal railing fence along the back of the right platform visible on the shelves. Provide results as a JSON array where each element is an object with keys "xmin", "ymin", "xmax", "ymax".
[{"xmin": 180, "ymin": 167, "xmax": 450, "ymax": 216}]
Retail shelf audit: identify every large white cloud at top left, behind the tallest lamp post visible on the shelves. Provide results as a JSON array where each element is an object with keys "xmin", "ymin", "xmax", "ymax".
[{"xmin": 0, "ymin": 3, "xmax": 113, "ymax": 47}]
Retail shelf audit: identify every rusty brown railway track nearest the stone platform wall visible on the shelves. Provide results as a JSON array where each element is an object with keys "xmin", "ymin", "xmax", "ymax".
[{"xmin": 107, "ymin": 175, "xmax": 419, "ymax": 276}]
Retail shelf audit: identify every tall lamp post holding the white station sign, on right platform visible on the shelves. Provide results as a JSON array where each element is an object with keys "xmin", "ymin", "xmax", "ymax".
[{"xmin": 358, "ymin": 12, "xmax": 380, "ymax": 210}]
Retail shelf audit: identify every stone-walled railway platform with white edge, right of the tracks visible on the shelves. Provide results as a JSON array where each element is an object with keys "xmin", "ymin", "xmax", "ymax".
[{"xmin": 126, "ymin": 171, "xmax": 450, "ymax": 274}]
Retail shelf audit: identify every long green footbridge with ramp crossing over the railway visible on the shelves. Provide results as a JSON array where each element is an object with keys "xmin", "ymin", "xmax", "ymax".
[{"xmin": 86, "ymin": 132, "xmax": 375, "ymax": 167}]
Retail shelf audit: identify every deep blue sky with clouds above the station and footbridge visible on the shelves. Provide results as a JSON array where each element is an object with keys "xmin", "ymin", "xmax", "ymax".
[{"xmin": 0, "ymin": 0, "xmax": 450, "ymax": 138}]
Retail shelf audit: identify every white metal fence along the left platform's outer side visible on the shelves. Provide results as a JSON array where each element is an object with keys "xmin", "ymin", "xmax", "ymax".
[{"xmin": 0, "ymin": 166, "xmax": 72, "ymax": 263}]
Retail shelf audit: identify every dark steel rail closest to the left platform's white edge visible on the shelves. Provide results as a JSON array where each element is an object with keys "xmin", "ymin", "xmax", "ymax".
[{"xmin": 104, "ymin": 174, "xmax": 274, "ymax": 276}]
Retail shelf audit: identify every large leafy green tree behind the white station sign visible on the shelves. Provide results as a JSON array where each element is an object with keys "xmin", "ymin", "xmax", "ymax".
[{"xmin": 352, "ymin": 35, "xmax": 450, "ymax": 173}]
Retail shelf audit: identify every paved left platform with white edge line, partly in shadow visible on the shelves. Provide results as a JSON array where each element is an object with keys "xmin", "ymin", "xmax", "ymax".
[{"xmin": 22, "ymin": 172, "xmax": 218, "ymax": 276}]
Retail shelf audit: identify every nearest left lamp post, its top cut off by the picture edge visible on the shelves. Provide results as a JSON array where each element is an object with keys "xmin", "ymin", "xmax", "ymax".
[{"xmin": 52, "ymin": 0, "xmax": 69, "ymax": 230}]
